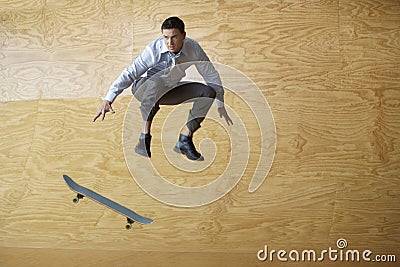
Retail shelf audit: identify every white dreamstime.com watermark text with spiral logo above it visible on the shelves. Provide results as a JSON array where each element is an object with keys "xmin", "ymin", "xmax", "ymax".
[{"xmin": 257, "ymin": 238, "xmax": 396, "ymax": 262}]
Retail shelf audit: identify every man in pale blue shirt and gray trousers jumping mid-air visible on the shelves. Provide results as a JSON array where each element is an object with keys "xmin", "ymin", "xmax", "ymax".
[{"xmin": 93, "ymin": 17, "xmax": 233, "ymax": 160}]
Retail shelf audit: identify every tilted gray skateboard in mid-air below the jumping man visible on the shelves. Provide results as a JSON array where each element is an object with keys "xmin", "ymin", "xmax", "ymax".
[{"xmin": 63, "ymin": 174, "xmax": 153, "ymax": 230}]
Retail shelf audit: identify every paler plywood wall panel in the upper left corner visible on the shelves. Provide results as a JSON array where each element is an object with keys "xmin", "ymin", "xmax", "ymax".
[{"xmin": 0, "ymin": 1, "xmax": 133, "ymax": 101}]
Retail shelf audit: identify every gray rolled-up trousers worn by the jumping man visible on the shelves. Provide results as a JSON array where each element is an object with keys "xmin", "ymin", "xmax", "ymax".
[{"xmin": 132, "ymin": 77, "xmax": 216, "ymax": 133}]
